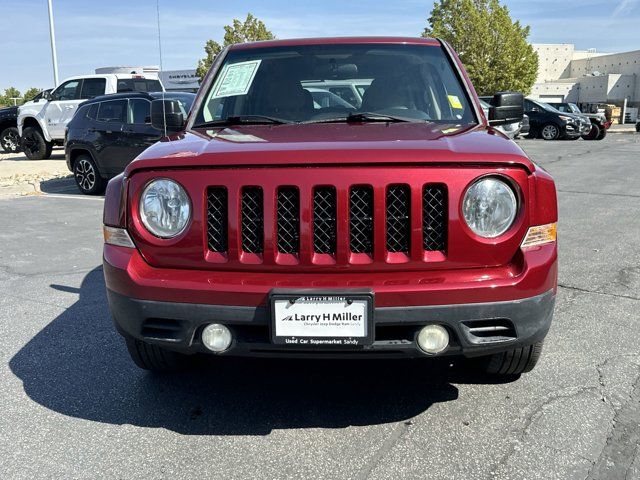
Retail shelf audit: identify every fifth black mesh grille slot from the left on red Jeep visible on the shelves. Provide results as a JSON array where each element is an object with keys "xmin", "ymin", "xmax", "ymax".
[{"xmin": 349, "ymin": 186, "xmax": 373, "ymax": 254}]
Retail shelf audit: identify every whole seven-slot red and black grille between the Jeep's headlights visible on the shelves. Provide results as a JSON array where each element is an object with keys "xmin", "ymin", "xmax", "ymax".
[{"xmin": 206, "ymin": 184, "xmax": 448, "ymax": 265}]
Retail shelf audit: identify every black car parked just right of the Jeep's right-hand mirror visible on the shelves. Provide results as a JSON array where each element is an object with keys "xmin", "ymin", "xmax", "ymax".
[{"xmin": 524, "ymin": 98, "xmax": 591, "ymax": 140}]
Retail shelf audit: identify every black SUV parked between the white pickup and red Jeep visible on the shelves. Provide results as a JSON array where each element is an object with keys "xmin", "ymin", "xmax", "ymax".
[{"xmin": 65, "ymin": 92, "xmax": 195, "ymax": 195}]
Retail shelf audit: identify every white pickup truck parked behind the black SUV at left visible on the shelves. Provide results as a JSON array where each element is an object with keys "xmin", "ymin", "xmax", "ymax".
[{"xmin": 18, "ymin": 74, "xmax": 164, "ymax": 160}]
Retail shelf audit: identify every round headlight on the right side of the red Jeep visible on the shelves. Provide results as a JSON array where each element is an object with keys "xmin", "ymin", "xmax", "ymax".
[{"xmin": 462, "ymin": 177, "xmax": 518, "ymax": 238}]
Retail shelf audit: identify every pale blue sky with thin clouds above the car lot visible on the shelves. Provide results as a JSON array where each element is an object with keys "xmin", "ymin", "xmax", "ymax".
[{"xmin": 0, "ymin": 0, "xmax": 640, "ymax": 92}]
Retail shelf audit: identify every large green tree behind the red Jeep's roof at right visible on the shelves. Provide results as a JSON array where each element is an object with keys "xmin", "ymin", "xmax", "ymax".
[{"xmin": 422, "ymin": 0, "xmax": 538, "ymax": 95}]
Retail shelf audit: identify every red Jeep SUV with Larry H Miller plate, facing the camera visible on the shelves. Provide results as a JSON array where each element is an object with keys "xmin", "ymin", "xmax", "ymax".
[{"xmin": 104, "ymin": 38, "xmax": 557, "ymax": 374}]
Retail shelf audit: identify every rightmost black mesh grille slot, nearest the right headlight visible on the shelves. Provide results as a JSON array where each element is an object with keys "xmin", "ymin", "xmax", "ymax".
[{"xmin": 422, "ymin": 185, "xmax": 447, "ymax": 251}]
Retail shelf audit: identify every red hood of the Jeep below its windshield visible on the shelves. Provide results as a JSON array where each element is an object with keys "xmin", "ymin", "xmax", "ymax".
[{"xmin": 126, "ymin": 123, "xmax": 535, "ymax": 175}]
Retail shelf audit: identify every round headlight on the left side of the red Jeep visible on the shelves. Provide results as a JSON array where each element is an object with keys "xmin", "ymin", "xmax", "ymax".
[{"xmin": 140, "ymin": 178, "xmax": 191, "ymax": 238}]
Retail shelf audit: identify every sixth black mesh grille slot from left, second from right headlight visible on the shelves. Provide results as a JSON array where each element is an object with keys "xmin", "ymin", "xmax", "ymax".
[{"xmin": 386, "ymin": 185, "xmax": 411, "ymax": 253}]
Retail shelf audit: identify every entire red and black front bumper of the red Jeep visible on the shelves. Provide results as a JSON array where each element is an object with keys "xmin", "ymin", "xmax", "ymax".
[{"xmin": 104, "ymin": 244, "xmax": 557, "ymax": 357}]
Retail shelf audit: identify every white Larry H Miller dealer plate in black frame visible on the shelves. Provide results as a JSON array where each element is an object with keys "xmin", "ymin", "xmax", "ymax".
[{"xmin": 271, "ymin": 294, "xmax": 373, "ymax": 348}]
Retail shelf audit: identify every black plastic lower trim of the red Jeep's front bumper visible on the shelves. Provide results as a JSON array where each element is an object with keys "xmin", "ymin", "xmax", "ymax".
[{"xmin": 107, "ymin": 291, "xmax": 555, "ymax": 357}]
